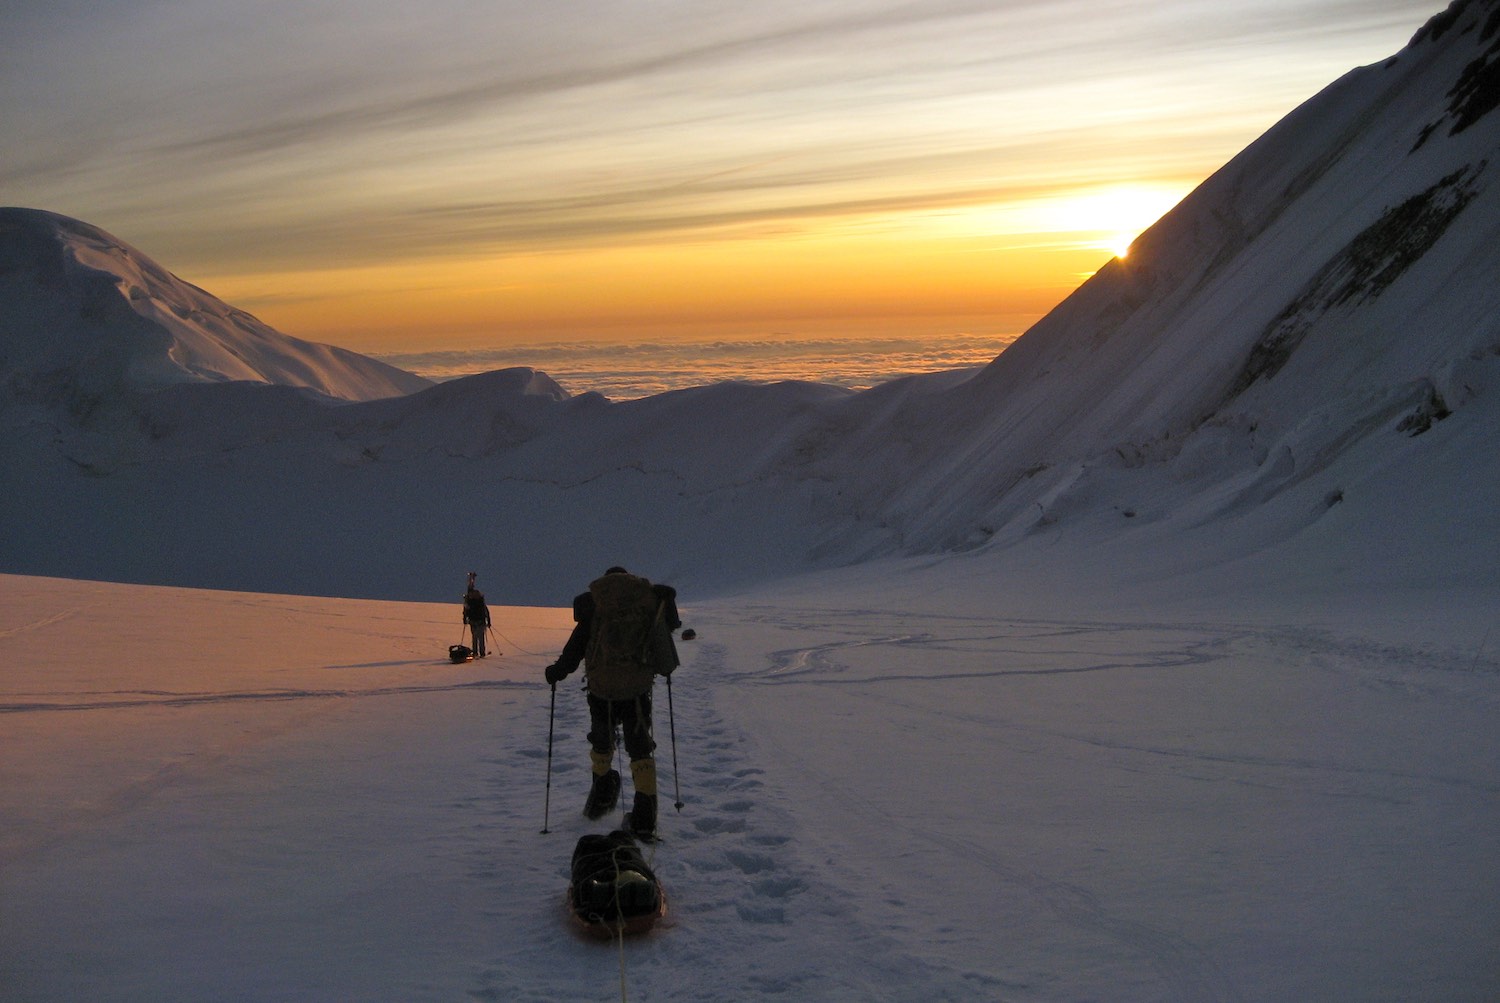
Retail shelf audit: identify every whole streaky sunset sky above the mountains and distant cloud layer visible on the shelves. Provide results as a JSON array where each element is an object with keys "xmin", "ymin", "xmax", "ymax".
[{"xmin": 0, "ymin": 0, "xmax": 1442, "ymax": 352}]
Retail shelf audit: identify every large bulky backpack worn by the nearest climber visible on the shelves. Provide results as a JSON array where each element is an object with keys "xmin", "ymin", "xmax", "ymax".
[{"xmin": 584, "ymin": 571, "xmax": 662, "ymax": 700}]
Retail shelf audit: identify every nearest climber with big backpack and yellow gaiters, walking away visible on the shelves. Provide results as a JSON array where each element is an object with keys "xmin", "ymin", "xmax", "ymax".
[{"xmin": 545, "ymin": 567, "xmax": 683, "ymax": 838}]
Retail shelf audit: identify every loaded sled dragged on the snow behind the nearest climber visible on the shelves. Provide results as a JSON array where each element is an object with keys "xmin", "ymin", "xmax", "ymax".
[{"xmin": 566, "ymin": 829, "xmax": 666, "ymax": 940}]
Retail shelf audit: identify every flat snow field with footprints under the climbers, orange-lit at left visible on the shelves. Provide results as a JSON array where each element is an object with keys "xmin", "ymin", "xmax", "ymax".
[{"xmin": 0, "ymin": 567, "xmax": 1500, "ymax": 1000}]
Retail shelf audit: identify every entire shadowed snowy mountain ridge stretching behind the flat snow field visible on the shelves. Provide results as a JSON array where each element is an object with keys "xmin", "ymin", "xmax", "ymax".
[{"xmin": 0, "ymin": 0, "xmax": 1500, "ymax": 603}]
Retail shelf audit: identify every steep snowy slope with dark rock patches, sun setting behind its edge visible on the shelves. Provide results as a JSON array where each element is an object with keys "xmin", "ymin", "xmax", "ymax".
[{"xmin": 822, "ymin": 3, "xmax": 1500, "ymax": 580}]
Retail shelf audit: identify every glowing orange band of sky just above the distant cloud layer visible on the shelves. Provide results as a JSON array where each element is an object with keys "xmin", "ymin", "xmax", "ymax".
[{"xmin": 196, "ymin": 196, "xmax": 1134, "ymax": 348}]
